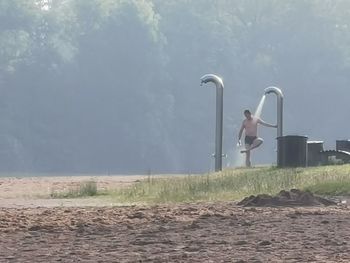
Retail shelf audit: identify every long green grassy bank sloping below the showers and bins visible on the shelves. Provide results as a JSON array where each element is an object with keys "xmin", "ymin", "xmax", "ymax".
[{"xmin": 109, "ymin": 165, "xmax": 350, "ymax": 203}]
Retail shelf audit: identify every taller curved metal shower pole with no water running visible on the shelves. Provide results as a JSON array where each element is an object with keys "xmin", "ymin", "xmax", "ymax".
[{"xmin": 201, "ymin": 74, "xmax": 224, "ymax": 172}]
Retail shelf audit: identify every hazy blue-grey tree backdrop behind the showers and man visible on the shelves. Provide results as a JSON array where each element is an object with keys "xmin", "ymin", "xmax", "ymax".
[{"xmin": 0, "ymin": 0, "xmax": 350, "ymax": 173}]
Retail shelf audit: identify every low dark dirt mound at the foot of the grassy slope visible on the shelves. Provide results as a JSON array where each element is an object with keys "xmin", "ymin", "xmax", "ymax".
[{"xmin": 238, "ymin": 189, "xmax": 337, "ymax": 206}]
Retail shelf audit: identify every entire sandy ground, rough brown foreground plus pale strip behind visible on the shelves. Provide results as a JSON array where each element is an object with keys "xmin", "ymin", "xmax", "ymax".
[{"xmin": 0, "ymin": 177, "xmax": 350, "ymax": 262}]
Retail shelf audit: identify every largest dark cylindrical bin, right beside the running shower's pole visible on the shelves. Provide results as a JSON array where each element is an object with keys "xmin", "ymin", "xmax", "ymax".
[{"xmin": 277, "ymin": 135, "xmax": 307, "ymax": 167}]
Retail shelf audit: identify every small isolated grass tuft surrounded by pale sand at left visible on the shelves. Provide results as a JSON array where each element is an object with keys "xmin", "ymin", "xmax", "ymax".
[{"xmin": 51, "ymin": 181, "xmax": 98, "ymax": 198}]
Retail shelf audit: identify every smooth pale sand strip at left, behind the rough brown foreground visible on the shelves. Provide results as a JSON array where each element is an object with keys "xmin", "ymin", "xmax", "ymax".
[{"xmin": 0, "ymin": 175, "xmax": 147, "ymax": 208}]
